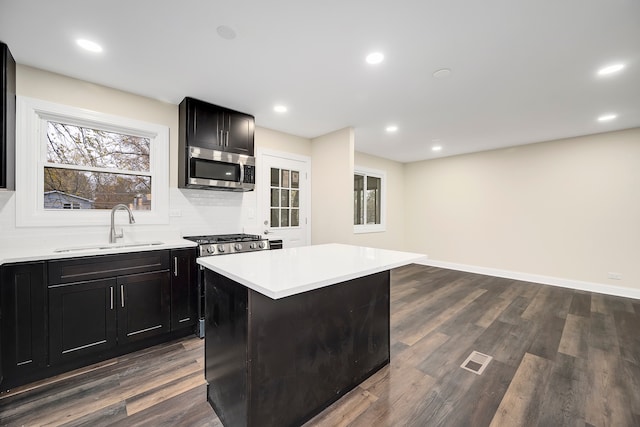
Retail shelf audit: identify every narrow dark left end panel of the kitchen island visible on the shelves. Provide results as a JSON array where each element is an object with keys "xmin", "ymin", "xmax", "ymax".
[{"xmin": 205, "ymin": 270, "xmax": 248, "ymax": 426}]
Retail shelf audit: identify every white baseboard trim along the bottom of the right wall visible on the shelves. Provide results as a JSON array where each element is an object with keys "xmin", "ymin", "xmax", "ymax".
[{"xmin": 418, "ymin": 259, "xmax": 640, "ymax": 299}]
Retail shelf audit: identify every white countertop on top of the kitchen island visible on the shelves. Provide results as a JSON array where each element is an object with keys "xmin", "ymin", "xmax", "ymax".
[{"xmin": 197, "ymin": 243, "xmax": 426, "ymax": 299}]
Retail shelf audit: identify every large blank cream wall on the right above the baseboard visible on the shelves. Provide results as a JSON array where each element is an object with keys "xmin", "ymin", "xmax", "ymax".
[{"xmin": 405, "ymin": 129, "xmax": 640, "ymax": 289}]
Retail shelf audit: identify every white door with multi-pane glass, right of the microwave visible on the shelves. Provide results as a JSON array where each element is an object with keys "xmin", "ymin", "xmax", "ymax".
[{"xmin": 258, "ymin": 152, "xmax": 311, "ymax": 248}]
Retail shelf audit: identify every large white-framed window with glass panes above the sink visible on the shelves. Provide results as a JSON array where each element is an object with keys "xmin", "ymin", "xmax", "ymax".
[{"xmin": 16, "ymin": 97, "xmax": 169, "ymax": 226}]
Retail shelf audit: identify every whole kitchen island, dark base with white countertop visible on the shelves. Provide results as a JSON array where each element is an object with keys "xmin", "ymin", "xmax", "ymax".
[{"xmin": 198, "ymin": 244, "xmax": 424, "ymax": 426}]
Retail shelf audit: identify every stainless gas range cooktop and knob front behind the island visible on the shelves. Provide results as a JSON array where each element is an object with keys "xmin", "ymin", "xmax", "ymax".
[{"xmin": 184, "ymin": 234, "xmax": 269, "ymax": 256}]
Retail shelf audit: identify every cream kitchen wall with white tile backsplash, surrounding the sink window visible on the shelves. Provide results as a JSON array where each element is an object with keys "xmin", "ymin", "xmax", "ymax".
[{"xmin": 0, "ymin": 64, "xmax": 310, "ymax": 243}]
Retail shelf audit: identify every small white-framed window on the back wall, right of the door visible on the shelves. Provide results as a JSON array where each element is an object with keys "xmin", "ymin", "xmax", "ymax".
[{"xmin": 353, "ymin": 167, "xmax": 386, "ymax": 233}]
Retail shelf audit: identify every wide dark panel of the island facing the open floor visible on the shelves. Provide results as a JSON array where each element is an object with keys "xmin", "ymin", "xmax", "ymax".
[{"xmin": 248, "ymin": 271, "xmax": 390, "ymax": 426}]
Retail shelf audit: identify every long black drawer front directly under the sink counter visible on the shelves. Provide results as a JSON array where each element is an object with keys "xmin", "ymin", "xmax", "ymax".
[{"xmin": 48, "ymin": 250, "xmax": 171, "ymax": 285}]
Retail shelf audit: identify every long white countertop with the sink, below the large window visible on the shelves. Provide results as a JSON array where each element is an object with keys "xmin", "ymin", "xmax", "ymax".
[{"xmin": 0, "ymin": 237, "xmax": 197, "ymax": 265}]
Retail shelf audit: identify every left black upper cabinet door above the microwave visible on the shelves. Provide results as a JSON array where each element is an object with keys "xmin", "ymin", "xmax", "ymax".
[{"xmin": 187, "ymin": 99, "xmax": 223, "ymax": 150}]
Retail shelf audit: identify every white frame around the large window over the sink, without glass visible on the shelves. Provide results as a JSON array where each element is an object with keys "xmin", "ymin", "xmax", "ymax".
[{"xmin": 16, "ymin": 96, "xmax": 169, "ymax": 227}]
